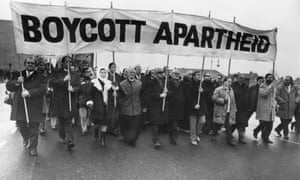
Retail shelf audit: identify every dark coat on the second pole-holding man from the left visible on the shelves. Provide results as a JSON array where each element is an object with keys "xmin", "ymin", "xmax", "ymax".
[{"xmin": 49, "ymin": 70, "xmax": 80, "ymax": 118}]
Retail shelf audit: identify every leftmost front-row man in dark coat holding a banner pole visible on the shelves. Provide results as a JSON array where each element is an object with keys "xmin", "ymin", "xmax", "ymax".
[{"xmin": 6, "ymin": 57, "xmax": 47, "ymax": 156}]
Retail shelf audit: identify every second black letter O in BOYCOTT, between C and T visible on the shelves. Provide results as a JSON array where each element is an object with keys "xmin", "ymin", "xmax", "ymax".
[{"xmin": 98, "ymin": 19, "xmax": 116, "ymax": 41}]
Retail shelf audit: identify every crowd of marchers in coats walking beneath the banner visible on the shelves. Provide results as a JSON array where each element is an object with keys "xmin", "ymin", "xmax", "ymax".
[{"xmin": 6, "ymin": 56, "xmax": 300, "ymax": 156}]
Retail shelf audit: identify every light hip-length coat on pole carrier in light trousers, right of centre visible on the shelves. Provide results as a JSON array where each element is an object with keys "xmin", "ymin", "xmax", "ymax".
[{"xmin": 212, "ymin": 86, "xmax": 237, "ymax": 124}]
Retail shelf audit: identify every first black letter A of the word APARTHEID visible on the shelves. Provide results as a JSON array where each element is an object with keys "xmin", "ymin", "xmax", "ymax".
[{"xmin": 153, "ymin": 22, "xmax": 172, "ymax": 44}]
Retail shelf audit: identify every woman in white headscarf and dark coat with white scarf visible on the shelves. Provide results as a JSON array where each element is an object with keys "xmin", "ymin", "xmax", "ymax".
[{"xmin": 86, "ymin": 68, "xmax": 112, "ymax": 147}]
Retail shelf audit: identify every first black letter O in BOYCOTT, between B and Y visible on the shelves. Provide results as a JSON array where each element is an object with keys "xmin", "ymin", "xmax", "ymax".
[{"xmin": 43, "ymin": 16, "xmax": 64, "ymax": 43}]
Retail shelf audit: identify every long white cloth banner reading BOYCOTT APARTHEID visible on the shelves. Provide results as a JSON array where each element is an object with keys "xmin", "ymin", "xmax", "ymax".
[{"xmin": 11, "ymin": 2, "xmax": 277, "ymax": 61}]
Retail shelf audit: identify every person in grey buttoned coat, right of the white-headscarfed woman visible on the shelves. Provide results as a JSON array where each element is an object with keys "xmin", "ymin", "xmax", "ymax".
[{"xmin": 119, "ymin": 68, "xmax": 142, "ymax": 146}]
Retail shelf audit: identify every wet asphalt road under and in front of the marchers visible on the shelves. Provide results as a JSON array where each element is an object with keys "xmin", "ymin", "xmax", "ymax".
[{"xmin": 0, "ymin": 84, "xmax": 300, "ymax": 180}]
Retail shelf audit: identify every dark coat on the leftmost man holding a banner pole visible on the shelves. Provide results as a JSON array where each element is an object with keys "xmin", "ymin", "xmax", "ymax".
[{"xmin": 6, "ymin": 71, "xmax": 47, "ymax": 122}]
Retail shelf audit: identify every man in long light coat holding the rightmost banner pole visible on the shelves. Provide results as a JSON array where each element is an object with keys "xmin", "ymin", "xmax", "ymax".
[{"xmin": 254, "ymin": 74, "xmax": 277, "ymax": 144}]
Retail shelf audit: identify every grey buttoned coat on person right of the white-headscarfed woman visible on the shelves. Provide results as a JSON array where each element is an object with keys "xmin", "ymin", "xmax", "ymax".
[{"xmin": 119, "ymin": 80, "xmax": 142, "ymax": 116}]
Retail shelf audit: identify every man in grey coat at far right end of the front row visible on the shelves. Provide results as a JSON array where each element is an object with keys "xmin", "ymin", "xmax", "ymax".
[{"xmin": 275, "ymin": 76, "xmax": 298, "ymax": 140}]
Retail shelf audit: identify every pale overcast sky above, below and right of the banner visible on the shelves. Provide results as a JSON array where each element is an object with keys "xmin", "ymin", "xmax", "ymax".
[{"xmin": 0, "ymin": 0, "xmax": 300, "ymax": 77}]
